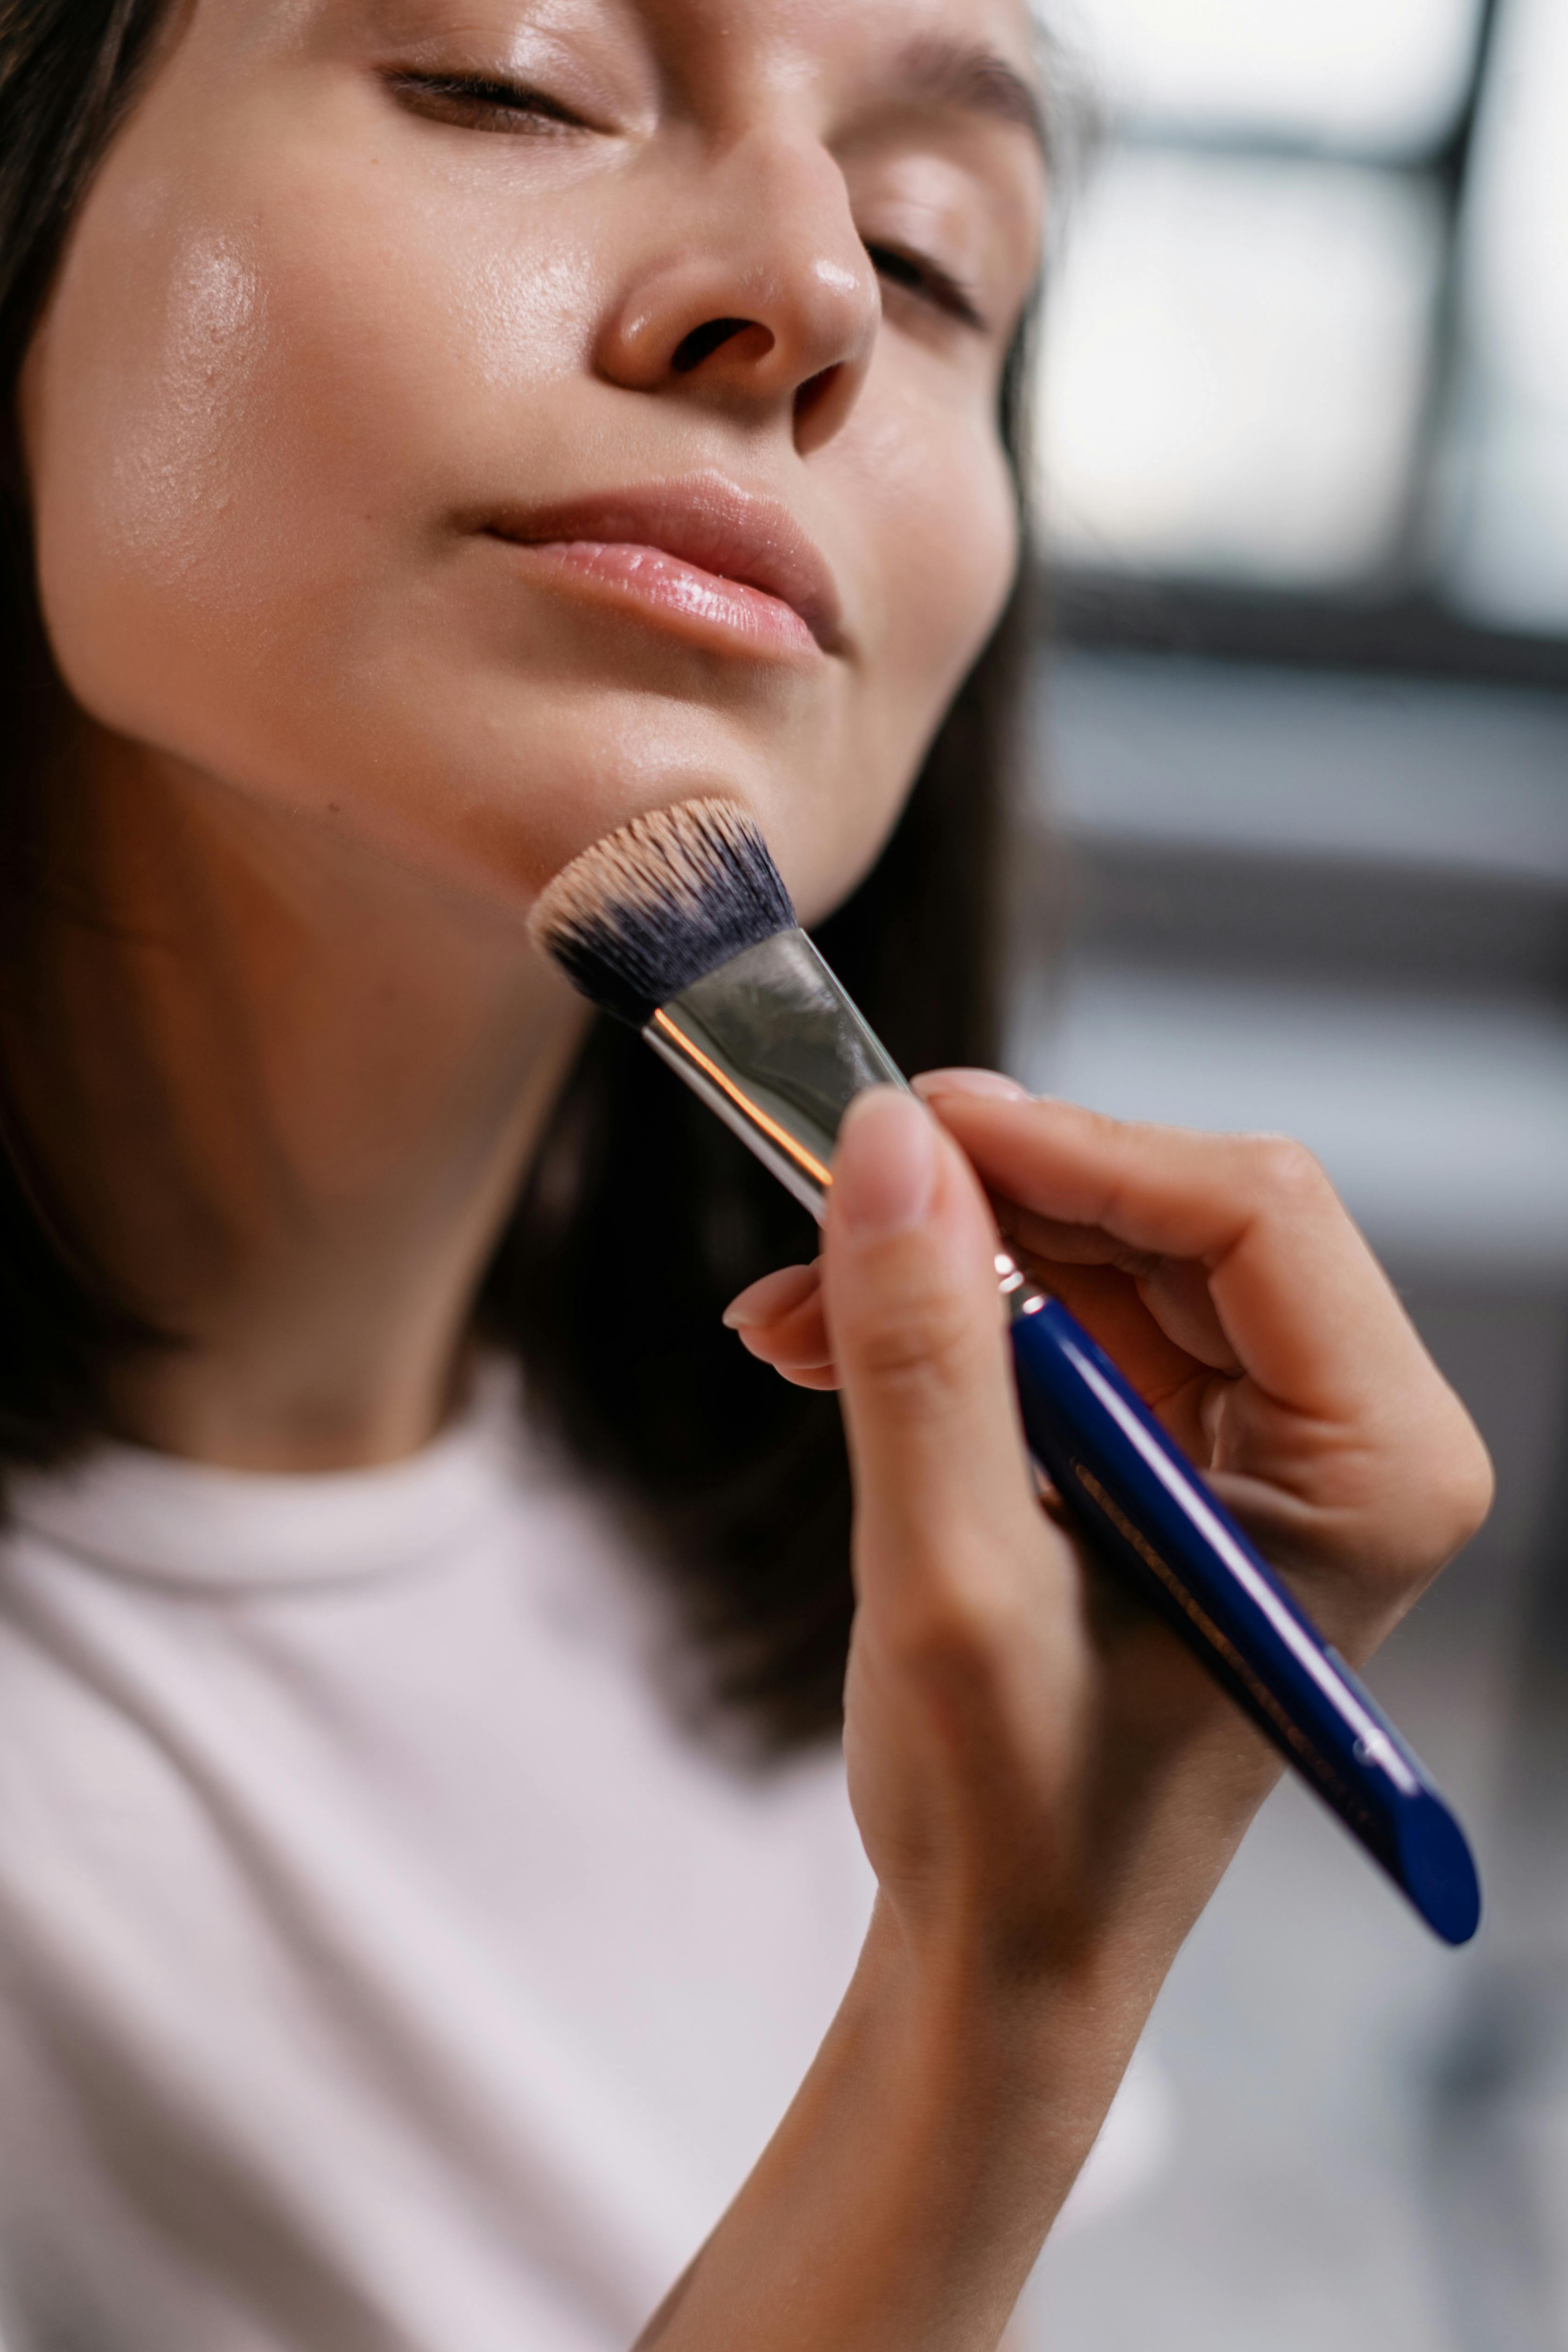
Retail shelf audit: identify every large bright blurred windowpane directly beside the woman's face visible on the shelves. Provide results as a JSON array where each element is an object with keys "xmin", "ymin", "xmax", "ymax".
[{"xmin": 1042, "ymin": 148, "xmax": 1441, "ymax": 583}]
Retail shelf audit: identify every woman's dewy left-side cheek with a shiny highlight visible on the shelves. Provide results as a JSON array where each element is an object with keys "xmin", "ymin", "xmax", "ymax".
[{"xmin": 23, "ymin": 132, "xmax": 581, "ymax": 821}]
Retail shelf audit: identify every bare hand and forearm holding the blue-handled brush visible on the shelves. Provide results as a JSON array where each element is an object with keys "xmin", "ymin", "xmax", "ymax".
[{"xmin": 642, "ymin": 1094, "xmax": 1491, "ymax": 2352}]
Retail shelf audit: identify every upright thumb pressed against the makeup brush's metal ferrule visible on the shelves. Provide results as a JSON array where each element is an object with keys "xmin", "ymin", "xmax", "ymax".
[{"xmin": 823, "ymin": 1086, "xmax": 1039, "ymax": 1583}]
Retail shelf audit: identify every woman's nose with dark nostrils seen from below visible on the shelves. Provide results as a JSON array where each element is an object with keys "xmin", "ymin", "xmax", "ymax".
[{"xmin": 595, "ymin": 136, "xmax": 882, "ymax": 456}]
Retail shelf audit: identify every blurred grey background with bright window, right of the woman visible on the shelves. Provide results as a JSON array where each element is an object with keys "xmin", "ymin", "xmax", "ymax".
[{"xmin": 1013, "ymin": 0, "xmax": 1568, "ymax": 2352}]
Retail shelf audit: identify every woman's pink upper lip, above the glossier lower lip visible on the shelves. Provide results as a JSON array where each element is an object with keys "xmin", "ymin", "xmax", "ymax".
[{"xmin": 489, "ymin": 473, "xmax": 844, "ymax": 651}]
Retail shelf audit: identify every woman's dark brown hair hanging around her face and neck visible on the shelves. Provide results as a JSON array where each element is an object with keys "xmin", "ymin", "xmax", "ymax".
[{"xmin": 0, "ymin": 0, "xmax": 1029, "ymax": 1743}]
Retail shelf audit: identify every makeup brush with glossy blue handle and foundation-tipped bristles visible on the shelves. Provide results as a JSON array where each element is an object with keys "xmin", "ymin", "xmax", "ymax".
[{"xmin": 531, "ymin": 800, "xmax": 1481, "ymax": 1943}]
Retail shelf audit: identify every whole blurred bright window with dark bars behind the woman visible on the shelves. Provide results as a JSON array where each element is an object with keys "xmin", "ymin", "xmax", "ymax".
[{"xmin": 1039, "ymin": 0, "xmax": 1568, "ymax": 661}]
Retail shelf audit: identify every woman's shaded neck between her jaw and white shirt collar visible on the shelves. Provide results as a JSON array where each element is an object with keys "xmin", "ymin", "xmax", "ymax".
[{"xmin": 0, "ymin": 736, "xmax": 583, "ymax": 1470}]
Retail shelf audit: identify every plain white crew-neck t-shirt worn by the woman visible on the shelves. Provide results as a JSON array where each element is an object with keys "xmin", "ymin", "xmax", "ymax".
[{"xmin": 0, "ymin": 1369, "xmax": 1152, "ymax": 2352}]
